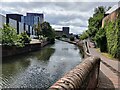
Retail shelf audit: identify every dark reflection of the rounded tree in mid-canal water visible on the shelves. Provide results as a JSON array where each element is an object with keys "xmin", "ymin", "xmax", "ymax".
[{"xmin": 36, "ymin": 48, "xmax": 55, "ymax": 60}]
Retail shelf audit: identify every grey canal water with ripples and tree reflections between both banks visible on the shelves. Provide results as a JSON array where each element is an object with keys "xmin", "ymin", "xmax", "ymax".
[{"xmin": 2, "ymin": 40, "xmax": 82, "ymax": 89}]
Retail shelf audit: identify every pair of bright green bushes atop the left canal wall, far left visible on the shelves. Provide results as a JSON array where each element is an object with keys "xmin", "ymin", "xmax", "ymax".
[{"xmin": 0, "ymin": 24, "xmax": 31, "ymax": 47}]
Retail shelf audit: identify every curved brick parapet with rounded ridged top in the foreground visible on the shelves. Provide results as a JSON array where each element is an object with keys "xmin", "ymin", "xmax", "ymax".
[{"xmin": 49, "ymin": 57, "xmax": 100, "ymax": 90}]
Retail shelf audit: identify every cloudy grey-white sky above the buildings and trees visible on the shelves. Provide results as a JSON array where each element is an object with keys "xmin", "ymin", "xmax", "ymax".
[{"xmin": 0, "ymin": 0, "xmax": 119, "ymax": 34}]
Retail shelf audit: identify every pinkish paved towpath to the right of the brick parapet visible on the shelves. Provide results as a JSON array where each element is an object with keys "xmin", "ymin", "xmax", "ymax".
[{"xmin": 89, "ymin": 44, "xmax": 120, "ymax": 90}]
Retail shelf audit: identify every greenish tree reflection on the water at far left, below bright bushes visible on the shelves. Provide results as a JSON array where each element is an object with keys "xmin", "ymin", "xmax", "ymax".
[{"xmin": 2, "ymin": 55, "xmax": 30, "ymax": 76}]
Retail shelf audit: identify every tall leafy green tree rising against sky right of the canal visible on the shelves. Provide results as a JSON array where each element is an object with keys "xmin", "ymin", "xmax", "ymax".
[{"xmin": 80, "ymin": 6, "xmax": 105, "ymax": 40}]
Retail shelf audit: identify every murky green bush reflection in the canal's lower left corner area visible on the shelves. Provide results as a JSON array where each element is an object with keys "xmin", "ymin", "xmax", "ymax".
[{"xmin": 2, "ymin": 59, "xmax": 30, "ymax": 86}]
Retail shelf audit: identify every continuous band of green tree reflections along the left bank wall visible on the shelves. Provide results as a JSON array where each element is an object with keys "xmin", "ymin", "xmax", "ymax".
[{"xmin": 2, "ymin": 48, "xmax": 55, "ymax": 81}]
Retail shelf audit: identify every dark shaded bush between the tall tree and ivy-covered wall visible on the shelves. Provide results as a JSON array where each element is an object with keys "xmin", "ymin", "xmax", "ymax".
[{"xmin": 95, "ymin": 28, "xmax": 107, "ymax": 52}]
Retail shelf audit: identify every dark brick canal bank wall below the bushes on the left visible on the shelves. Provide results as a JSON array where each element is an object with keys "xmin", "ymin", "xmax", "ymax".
[{"xmin": 0, "ymin": 41, "xmax": 50, "ymax": 57}]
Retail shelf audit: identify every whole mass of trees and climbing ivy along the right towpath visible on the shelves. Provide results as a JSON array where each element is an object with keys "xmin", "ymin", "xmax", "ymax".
[{"xmin": 80, "ymin": 6, "xmax": 120, "ymax": 59}]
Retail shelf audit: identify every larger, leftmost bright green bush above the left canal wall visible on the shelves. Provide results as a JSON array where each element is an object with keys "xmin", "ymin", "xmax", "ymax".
[{"xmin": 0, "ymin": 24, "xmax": 23, "ymax": 47}]
